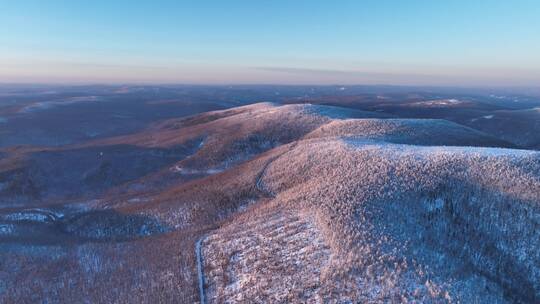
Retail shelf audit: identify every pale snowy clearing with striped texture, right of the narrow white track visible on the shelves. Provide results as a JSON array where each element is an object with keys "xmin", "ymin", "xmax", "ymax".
[{"xmin": 203, "ymin": 212, "xmax": 330, "ymax": 303}]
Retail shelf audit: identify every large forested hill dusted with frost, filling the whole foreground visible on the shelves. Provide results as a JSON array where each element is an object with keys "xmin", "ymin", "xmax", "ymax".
[{"xmin": 0, "ymin": 103, "xmax": 540, "ymax": 303}]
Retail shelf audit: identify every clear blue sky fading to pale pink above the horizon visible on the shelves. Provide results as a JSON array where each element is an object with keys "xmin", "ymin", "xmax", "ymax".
[{"xmin": 0, "ymin": 0, "xmax": 540, "ymax": 87}]
